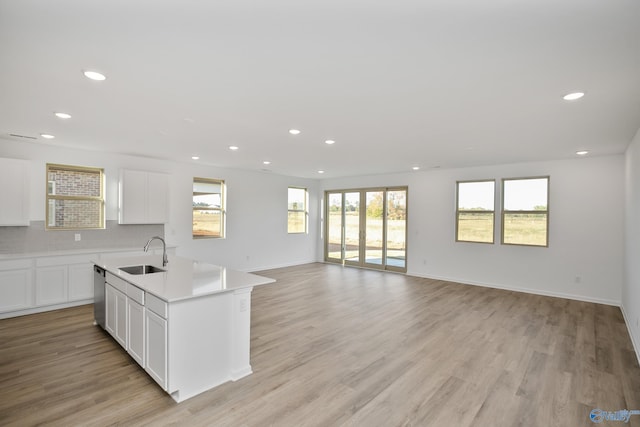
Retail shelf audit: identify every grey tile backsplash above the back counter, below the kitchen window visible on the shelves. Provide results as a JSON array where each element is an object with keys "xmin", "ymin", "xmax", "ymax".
[{"xmin": 0, "ymin": 221, "xmax": 164, "ymax": 255}]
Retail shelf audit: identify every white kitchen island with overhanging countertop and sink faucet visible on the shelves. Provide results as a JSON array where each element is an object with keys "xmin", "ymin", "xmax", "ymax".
[{"xmin": 95, "ymin": 256, "xmax": 274, "ymax": 402}]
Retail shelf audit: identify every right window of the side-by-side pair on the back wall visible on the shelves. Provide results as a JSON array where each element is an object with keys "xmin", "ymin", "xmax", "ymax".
[{"xmin": 502, "ymin": 177, "xmax": 549, "ymax": 246}]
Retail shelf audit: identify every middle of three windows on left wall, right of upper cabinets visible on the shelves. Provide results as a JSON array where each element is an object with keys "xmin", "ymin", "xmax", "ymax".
[{"xmin": 193, "ymin": 178, "xmax": 225, "ymax": 239}]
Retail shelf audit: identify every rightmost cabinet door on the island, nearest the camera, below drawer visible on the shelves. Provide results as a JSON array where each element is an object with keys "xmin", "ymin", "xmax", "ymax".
[{"xmin": 145, "ymin": 310, "xmax": 167, "ymax": 390}]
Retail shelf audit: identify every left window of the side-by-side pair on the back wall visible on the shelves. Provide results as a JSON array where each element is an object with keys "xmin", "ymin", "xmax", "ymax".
[{"xmin": 456, "ymin": 180, "xmax": 496, "ymax": 243}]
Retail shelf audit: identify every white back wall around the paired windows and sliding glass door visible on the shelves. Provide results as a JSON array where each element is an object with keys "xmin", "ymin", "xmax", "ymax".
[{"xmin": 318, "ymin": 156, "xmax": 624, "ymax": 305}]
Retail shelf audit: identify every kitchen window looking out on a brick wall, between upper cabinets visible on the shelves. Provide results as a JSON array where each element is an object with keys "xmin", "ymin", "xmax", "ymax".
[{"xmin": 46, "ymin": 164, "xmax": 104, "ymax": 230}]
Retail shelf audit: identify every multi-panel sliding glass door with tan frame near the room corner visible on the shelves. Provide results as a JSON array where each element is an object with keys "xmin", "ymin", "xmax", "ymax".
[{"xmin": 325, "ymin": 187, "xmax": 407, "ymax": 272}]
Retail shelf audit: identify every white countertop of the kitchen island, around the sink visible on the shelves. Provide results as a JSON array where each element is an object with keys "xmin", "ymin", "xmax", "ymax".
[{"xmin": 94, "ymin": 255, "xmax": 275, "ymax": 302}]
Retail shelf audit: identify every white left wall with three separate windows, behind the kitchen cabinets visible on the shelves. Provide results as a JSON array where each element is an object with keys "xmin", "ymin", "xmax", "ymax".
[{"xmin": 0, "ymin": 139, "xmax": 318, "ymax": 270}]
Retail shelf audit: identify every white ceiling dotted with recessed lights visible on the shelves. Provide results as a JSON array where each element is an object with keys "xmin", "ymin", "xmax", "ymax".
[{"xmin": 0, "ymin": 0, "xmax": 640, "ymax": 178}]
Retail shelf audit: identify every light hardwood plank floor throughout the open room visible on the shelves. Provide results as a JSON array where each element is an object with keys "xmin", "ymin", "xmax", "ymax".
[{"xmin": 0, "ymin": 264, "xmax": 640, "ymax": 427}]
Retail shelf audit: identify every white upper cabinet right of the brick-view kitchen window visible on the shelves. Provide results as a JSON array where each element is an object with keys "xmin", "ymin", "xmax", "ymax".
[{"xmin": 118, "ymin": 169, "xmax": 169, "ymax": 224}]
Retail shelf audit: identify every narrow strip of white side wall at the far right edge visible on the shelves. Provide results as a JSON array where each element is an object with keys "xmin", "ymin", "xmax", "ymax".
[{"xmin": 622, "ymin": 130, "xmax": 640, "ymax": 354}]
